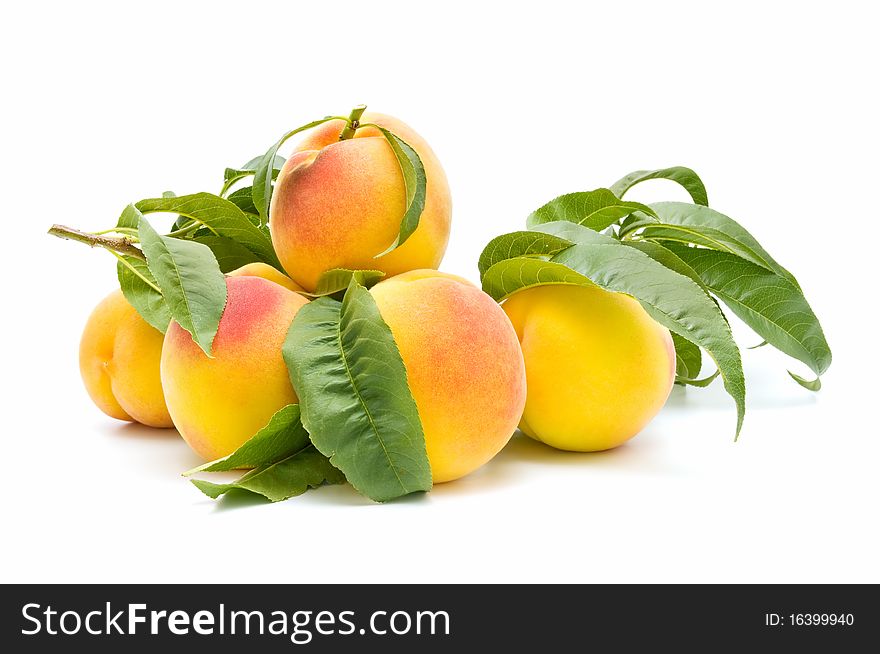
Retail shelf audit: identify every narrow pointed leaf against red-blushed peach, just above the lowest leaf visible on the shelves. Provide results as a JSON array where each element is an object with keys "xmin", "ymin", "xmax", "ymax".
[{"xmin": 183, "ymin": 404, "xmax": 310, "ymax": 476}]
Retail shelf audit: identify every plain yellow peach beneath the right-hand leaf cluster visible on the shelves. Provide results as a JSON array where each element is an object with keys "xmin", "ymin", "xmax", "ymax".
[{"xmin": 502, "ymin": 285, "xmax": 675, "ymax": 452}]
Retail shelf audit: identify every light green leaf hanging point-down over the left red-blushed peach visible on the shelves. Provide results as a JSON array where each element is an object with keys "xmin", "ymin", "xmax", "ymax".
[{"xmin": 138, "ymin": 218, "xmax": 226, "ymax": 357}]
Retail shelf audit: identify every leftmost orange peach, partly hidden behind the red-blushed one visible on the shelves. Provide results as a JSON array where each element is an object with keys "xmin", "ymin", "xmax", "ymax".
[{"xmin": 79, "ymin": 290, "xmax": 173, "ymax": 427}]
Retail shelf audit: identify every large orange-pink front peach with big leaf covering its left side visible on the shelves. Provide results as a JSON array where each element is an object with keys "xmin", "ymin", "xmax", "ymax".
[{"xmin": 371, "ymin": 270, "xmax": 526, "ymax": 483}]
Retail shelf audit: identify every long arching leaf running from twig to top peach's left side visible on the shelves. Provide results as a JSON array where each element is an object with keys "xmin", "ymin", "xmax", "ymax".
[{"xmin": 137, "ymin": 193, "xmax": 281, "ymax": 270}]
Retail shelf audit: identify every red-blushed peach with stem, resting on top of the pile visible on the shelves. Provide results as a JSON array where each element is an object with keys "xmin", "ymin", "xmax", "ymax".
[{"xmin": 269, "ymin": 113, "xmax": 452, "ymax": 291}]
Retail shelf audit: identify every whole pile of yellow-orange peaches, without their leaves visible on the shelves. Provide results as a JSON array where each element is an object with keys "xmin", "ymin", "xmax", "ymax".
[{"xmin": 69, "ymin": 109, "xmax": 676, "ymax": 502}]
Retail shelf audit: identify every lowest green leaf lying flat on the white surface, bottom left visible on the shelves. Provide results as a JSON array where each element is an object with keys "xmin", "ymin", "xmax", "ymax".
[{"xmin": 190, "ymin": 447, "xmax": 345, "ymax": 502}]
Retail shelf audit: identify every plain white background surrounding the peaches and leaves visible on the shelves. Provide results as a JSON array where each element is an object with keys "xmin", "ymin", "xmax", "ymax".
[{"xmin": 0, "ymin": 0, "xmax": 880, "ymax": 582}]
